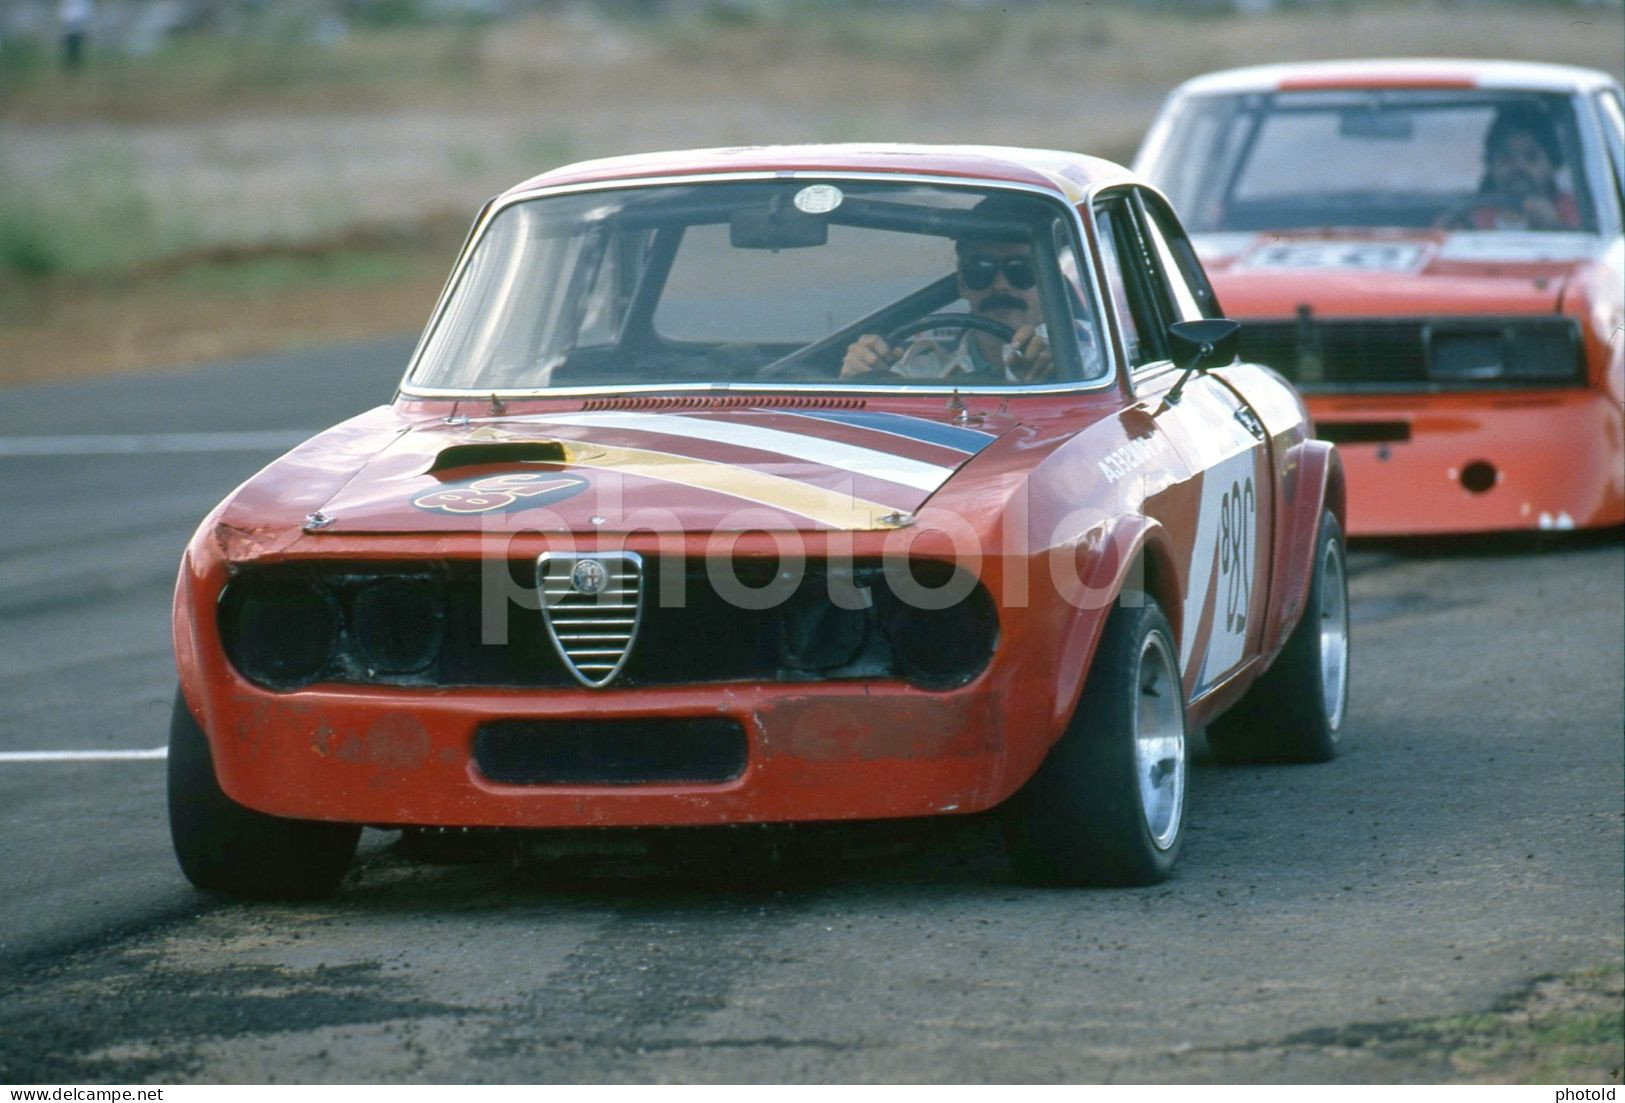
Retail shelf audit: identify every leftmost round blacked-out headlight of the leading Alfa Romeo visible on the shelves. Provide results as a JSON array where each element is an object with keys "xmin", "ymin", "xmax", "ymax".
[{"xmin": 219, "ymin": 575, "xmax": 340, "ymax": 689}]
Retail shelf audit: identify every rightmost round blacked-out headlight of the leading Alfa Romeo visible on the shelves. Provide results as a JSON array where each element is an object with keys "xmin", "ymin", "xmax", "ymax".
[{"xmin": 876, "ymin": 564, "xmax": 999, "ymax": 689}]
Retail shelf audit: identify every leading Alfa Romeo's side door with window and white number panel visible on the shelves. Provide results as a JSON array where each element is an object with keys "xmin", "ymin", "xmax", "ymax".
[{"xmin": 1095, "ymin": 188, "xmax": 1274, "ymax": 700}]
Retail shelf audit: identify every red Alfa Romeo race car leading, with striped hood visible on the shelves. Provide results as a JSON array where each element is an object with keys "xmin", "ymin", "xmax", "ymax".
[{"xmin": 169, "ymin": 146, "xmax": 1349, "ymax": 897}]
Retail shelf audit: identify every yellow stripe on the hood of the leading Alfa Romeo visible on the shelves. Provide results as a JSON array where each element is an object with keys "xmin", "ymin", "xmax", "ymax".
[{"xmin": 564, "ymin": 440, "xmax": 895, "ymax": 530}]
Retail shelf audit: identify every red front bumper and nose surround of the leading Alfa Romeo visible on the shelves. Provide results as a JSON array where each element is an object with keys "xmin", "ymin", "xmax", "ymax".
[{"xmin": 172, "ymin": 521, "xmax": 1108, "ymax": 827}]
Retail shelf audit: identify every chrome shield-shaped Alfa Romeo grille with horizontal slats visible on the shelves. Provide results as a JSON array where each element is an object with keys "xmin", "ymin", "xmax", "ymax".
[{"xmin": 536, "ymin": 552, "xmax": 644, "ymax": 689}]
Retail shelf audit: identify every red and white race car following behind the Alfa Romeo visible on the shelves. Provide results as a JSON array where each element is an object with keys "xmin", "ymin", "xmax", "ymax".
[{"xmin": 1136, "ymin": 60, "xmax": 1625, "ymax": 536}]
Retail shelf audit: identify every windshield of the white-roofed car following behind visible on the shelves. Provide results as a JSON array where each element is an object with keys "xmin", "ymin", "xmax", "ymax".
[{"xmin": 1142, "ymin": 89, "xmax": 1596, "ymax": 232}]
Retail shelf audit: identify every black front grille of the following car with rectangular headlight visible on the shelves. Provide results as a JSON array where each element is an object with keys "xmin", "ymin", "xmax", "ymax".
[{"xmin": 1240, "ymin": 314, "xmax": 1583, "ymax": 391}]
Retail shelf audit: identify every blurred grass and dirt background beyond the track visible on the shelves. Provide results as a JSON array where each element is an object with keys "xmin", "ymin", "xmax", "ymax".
[{"xmin": 0, "ymin": 0, "xmax": 1625, "ymax": 380}]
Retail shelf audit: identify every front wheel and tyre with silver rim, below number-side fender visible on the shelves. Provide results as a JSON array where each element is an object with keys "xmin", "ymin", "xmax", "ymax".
[{"xmin": 1004, "ymin": 596, "xmax": 1186, "ymax": 885}]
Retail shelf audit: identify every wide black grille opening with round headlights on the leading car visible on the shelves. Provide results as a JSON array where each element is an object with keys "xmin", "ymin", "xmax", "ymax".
[{"xmin": 219, "ymin": 552, "xmax": 999, "ymax": 689}]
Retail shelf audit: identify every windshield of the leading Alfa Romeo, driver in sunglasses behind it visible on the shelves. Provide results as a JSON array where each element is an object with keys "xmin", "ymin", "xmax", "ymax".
[{"xmin": 410, "ymin": 179, "xmax": 1105, "ymax": 393}]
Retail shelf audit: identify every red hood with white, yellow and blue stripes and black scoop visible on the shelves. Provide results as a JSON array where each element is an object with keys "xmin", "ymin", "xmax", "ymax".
[{"xmin": 284, "ymin": 403, "xmax": 1012, "ymax": 533}]
